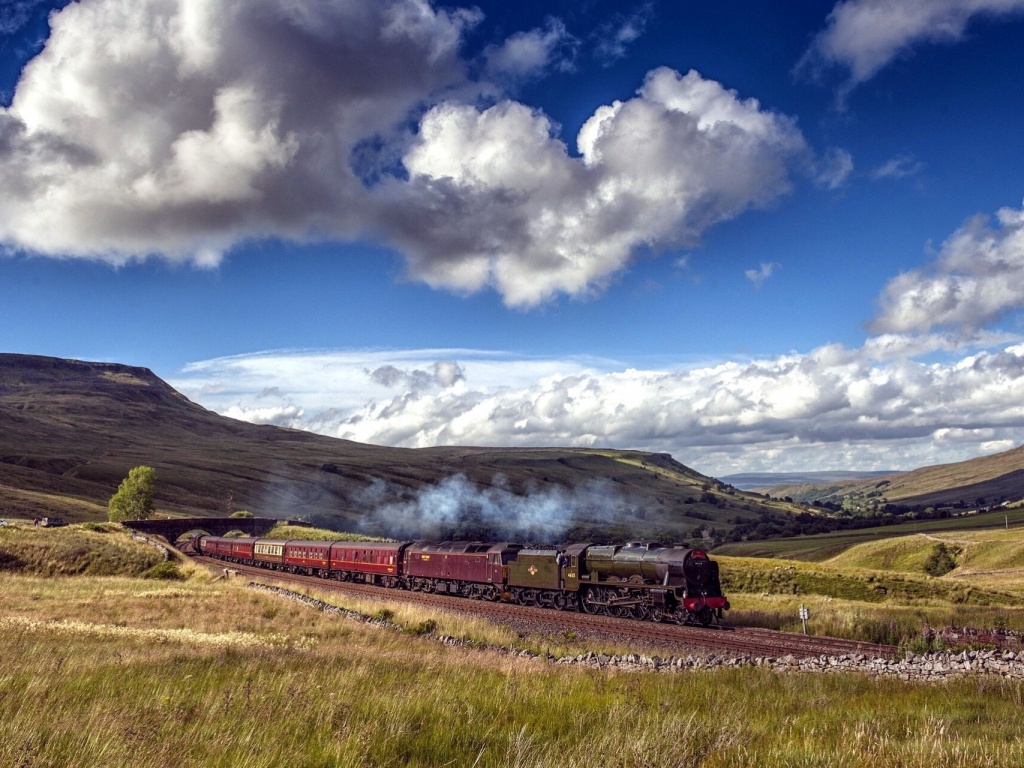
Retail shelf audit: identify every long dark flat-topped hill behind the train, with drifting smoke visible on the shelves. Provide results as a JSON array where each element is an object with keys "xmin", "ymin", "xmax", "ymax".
[{"xmin": 0, "ymin": 354, "xmax": 788, "ymax": 540}]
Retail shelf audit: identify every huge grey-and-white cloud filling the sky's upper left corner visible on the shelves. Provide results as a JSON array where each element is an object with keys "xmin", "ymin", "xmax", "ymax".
[{"xmin": 0, "ymin": 0, "xmax": 478, "ymax": 263}]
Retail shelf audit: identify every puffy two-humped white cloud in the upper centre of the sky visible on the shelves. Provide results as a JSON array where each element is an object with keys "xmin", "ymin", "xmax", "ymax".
[{"xmin": 400, "ymin": 68, "xmax": 806, "ymax": 306}]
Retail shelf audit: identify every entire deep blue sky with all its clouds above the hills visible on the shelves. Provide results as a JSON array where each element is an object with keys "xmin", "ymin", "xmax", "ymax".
[{"xmin": 0, "ymin": 0, "xmax": 1024, "ymax": 475}]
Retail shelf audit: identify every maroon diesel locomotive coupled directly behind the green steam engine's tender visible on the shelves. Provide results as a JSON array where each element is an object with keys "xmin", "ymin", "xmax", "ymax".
[{"xmin": 402, "ymin": 542, "xmax": 522, "ymax": 600}]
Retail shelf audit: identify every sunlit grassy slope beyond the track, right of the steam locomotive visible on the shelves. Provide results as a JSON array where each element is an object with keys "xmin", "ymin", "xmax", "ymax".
[{"xmin": 717, "ymin": 518, "xmax": 1024, "ymax": 649}]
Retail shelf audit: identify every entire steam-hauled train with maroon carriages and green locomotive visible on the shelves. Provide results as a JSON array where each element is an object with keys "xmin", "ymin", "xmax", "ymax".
[{"xmin": 193, "ymin": 536, "xmax": 729, "ymax": 626}]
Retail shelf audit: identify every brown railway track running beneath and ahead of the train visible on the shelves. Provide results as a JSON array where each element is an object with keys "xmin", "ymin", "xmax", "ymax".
[{"xmin": 195, "ymin": 557, "xmax": 897, "ymax": 658}]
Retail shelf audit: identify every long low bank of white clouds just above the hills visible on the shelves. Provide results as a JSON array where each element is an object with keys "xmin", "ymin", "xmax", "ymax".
[{"xmin": 172, "ymin": 336, "xmax": 1024, "ymax": 475}]
